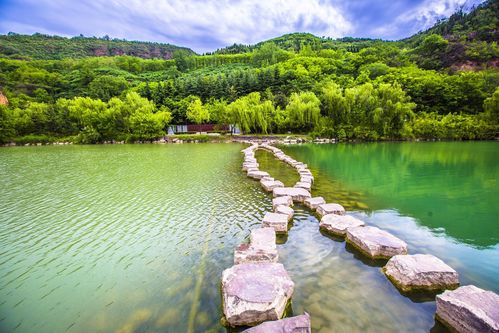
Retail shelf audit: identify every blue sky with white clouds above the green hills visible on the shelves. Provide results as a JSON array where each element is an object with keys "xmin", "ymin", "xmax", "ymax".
[{"xmin": 0, "ymin": 0, "xmax": 483, "ymax": 53}]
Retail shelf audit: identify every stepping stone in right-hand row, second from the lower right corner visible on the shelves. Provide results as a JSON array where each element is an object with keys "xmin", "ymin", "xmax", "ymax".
[{"xmin": 383, "ymin": 254, "xmax": 459, "ymax": 292}]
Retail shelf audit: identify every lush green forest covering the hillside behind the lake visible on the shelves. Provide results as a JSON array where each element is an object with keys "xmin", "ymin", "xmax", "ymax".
[{"xmin": 0, "ymin": 0, "xmax": 499, "ymax": 143}]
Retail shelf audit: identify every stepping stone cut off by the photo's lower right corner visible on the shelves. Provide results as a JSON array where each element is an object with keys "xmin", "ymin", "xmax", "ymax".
[{"xmin": 436, "ymin": 285, "xmax": 499, "ymax": 333}]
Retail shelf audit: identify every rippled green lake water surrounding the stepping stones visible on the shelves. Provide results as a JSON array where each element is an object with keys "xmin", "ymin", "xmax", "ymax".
[{"xmin": 0, "ymin": 142, "xmax": 499, "ymax": 333}]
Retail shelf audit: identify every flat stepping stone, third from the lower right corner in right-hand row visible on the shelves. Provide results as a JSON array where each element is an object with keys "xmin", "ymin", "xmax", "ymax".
[{"xmin": 346, "ymin": 224, "xmax": 407, "ymax": 259}]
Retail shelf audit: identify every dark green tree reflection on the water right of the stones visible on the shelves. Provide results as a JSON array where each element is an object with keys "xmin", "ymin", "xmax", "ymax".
[{"xmin": 285, "ymin": 142, "xmax": 499, "ymax": 246}]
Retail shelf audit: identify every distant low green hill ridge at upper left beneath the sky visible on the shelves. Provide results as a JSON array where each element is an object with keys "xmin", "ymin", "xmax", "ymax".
[{"xmin": 0, "ymin": 33, "xmax": 195, "ymax": 60}]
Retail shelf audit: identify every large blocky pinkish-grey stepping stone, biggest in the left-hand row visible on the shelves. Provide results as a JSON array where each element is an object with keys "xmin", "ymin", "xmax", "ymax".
[{"xmin": 222, "ymin": 263, "xmax": 294, "ymax": 327}]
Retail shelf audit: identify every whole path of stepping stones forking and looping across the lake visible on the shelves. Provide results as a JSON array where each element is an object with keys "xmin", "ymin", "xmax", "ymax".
[{"xmin": 222, "ymin": 142, "xmax": 499, "ymax": 333}]
